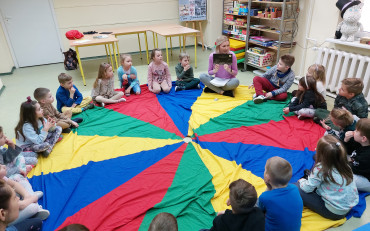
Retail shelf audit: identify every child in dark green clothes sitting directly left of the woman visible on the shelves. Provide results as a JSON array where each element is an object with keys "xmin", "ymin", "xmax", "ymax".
[{"xmin": 175, "ymin": 53, "xmax": 200, "ymax": 91}]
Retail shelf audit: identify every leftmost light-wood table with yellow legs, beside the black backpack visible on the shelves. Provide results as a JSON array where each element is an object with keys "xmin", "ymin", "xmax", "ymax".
[{"xmin": 69, "ymin": 34, "xmax": 118, "ymax": 86}]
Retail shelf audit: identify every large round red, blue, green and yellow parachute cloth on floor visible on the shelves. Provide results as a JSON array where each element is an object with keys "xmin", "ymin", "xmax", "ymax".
[{"xmin": 28, "ymin": 85, "xmax": 368, "ymax": 231}]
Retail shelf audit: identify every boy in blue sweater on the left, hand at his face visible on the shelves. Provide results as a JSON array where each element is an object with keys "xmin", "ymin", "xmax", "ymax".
[{"xmin": 56, "ymin": 73, "xmax": 94, "ymax": 114}]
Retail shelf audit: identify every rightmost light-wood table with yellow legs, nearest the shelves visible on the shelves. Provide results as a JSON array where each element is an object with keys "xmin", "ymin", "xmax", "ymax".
[{"xmin": 150, "ymin": 24, "xmax": 199, "ymax": 68}]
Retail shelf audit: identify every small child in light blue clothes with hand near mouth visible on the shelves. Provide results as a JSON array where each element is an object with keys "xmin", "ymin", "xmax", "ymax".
[{"xmin": 117, "ymin": 54, "xmax": 141, "ymax": 96}]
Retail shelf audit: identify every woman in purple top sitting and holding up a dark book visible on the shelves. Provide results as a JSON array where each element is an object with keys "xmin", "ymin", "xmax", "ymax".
[{"xmin": 199, "ymin": 35, "xmax": 239, "ymax": 97}]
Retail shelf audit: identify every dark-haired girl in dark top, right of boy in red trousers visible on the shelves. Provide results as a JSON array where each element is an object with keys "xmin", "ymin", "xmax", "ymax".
[{"xmin": 283, "ymin": 76, "xmax": 326, "ymax": 119}]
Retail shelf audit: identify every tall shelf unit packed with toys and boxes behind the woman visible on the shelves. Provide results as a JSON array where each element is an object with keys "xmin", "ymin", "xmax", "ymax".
[{"xmin": 222, "ymin": 0, "xmax": 299, "ymax": 70}]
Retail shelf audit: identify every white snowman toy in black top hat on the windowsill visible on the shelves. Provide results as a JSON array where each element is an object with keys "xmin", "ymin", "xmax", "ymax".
[{"xmin": 335, "ymin": 0, "xmax": 363, "ymax": 42}]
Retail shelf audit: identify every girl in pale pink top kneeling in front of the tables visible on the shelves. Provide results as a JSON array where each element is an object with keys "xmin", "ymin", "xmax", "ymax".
[{"xmin": 148, "ymin": 48, "xmax": 172, "ymax": 94}]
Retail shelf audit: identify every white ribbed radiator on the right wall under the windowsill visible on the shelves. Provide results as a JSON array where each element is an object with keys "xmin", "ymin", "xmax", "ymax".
[{"xmin": 313, "ymin": 47, "xmax": 370, "ymax": 104}]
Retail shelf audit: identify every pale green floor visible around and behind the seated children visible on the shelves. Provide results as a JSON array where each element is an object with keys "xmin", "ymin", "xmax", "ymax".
[{"xmin": 0, "ymin": 48, "xmax": 370, "ymax": 231}]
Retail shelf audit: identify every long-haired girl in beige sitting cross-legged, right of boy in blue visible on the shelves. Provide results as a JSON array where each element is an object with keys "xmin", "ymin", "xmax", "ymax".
[{"xmin": 91, "ymin": 63, "xmax": 126, "ymax": 104}]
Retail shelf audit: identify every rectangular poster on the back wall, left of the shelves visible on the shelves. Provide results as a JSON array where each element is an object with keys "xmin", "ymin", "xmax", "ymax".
[{"xmin": 179, "ymin": 0, "xmax": 207, "ymax": 22}]
